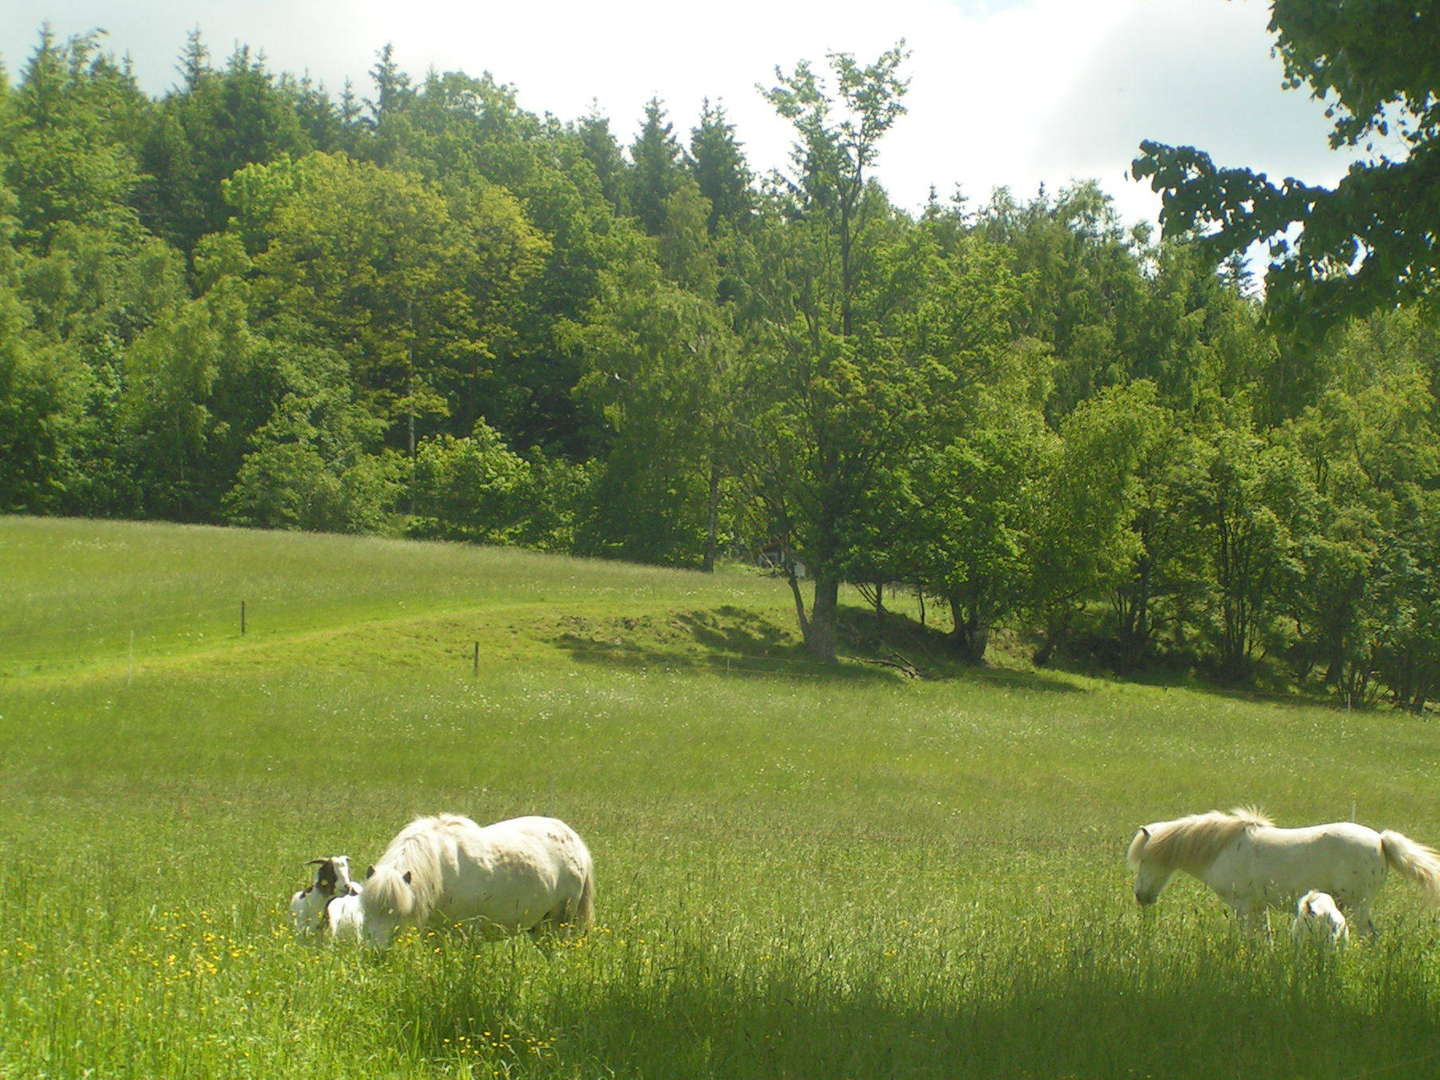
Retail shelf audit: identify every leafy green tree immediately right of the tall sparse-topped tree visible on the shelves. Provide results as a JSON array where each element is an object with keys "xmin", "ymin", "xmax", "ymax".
[{"xmin": 851, "ymin": 230, "xmax": 1054, "ymax": 662}]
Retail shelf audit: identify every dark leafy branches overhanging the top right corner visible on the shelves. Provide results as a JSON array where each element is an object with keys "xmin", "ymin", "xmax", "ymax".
[{"xmin": 1133, "ymin": 0, "xmax": 1440, "ymax": 338}]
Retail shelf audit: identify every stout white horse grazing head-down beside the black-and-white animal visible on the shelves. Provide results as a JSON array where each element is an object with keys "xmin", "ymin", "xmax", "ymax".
[{"xmin": 360, "ymin": 814, "xmax": 595, "ymax": 948}]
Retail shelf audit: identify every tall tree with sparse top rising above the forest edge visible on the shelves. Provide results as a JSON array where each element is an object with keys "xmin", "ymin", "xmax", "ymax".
[{"xmin": 750, "ymin": 48, "xmax": 910, "ymax": 660}]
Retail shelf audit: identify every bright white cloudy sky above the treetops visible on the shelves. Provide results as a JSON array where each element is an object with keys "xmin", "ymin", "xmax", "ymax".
[{"xmin": 0, "ymin": 0, "xmax": 1348, "ymax": 222}]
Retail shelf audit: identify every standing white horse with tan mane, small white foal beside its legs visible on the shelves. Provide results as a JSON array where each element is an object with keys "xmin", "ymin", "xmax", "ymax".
[{"xmin": 1126, "ymin": 809, "xmax": 1440, "ymax": 935}]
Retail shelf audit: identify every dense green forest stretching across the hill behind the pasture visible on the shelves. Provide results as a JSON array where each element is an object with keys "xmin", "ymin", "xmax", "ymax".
[{"xmin": 0, "ymin": 30, "xmax": 1440, "ymax": 710}]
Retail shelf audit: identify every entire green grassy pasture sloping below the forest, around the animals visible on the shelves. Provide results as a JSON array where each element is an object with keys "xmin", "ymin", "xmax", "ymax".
[{"xmin": 0, "ymin": 517, "xmax": 1440, "ymax": 1080}]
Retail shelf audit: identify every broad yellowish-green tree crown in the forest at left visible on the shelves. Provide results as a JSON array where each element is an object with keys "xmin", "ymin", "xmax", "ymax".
[{"xmin": 255, "ymin": 154, "xmax": 544, "ymax": 451}]
